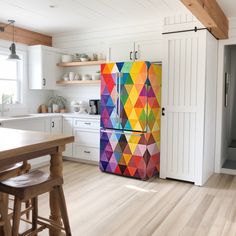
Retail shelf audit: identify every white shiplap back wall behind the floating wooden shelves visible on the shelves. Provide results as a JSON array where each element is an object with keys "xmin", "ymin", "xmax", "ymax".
[{"xmin": 53, "ymin": 21, "xmax": 163, "ymax": 105}]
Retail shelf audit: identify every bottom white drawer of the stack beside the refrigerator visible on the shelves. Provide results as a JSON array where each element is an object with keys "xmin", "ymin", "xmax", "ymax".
[{"xmin": 73, "ymin": 144, "xmax": 99, "ymax": 162}]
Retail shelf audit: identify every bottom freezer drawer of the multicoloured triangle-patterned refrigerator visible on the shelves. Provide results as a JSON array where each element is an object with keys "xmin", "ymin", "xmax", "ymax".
[{"xmin": 99, "ymin": 130, "xmax": 160, "ymax": 179}]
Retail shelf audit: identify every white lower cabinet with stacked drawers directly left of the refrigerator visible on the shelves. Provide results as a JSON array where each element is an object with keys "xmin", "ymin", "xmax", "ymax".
[{"xmin": 63, "ymin": 117, "xmax": 100, "ymax": 163}]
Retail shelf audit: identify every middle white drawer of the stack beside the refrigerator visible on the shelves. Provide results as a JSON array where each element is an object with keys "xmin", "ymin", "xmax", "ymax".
[{"xmin": 74, "ymin": 129, "xmax": 100, "ymax": 147}]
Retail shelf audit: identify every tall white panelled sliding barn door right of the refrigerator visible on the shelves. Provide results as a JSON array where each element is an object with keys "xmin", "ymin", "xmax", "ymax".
[{"xmin": 160, "ymin": 31, "xmax": 206, "ymax": 184}]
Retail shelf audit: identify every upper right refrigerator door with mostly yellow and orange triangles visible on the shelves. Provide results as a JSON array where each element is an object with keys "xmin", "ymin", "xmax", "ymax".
[{"xmin": 118, "ymin": 61, "xmax": 148, "ymax": 132}]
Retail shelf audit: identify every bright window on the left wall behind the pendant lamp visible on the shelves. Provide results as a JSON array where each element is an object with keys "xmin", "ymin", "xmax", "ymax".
[{"xmin": 0, "ymin": 52, "xmax": 21, "ymax": 103}]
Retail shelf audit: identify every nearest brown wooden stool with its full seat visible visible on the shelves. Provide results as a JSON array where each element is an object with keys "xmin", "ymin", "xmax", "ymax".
[{"xmin": 0, "ymin": 170, "xmax": 71, "ymax": 236}]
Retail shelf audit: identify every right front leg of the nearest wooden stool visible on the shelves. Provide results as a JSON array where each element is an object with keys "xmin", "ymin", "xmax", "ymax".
[{"xmin": 55, "ymin": 185, "xmax": 72, "ymax": 236}]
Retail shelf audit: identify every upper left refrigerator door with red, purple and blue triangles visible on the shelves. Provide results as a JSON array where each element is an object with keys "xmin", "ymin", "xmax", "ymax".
[{"xmin": 101, "ymin": 63, "xmax": 121, "ymax": 129}]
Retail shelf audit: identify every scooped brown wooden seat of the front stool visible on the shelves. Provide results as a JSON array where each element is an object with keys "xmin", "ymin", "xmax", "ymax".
[{"xmin": 0, "ymin": 170, "xmax": 63, "ymax": 200}]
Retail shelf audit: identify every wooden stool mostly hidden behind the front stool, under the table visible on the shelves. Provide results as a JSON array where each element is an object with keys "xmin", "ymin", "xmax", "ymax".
[{"xmin": 0, "ymin": 161, "xmax": 31, "ymax": 235}]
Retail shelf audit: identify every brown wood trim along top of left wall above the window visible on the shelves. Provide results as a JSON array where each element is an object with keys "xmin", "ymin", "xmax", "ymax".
[{"xmin": 0, "ymin": 23, "xmax": 52, "ymax": 47}]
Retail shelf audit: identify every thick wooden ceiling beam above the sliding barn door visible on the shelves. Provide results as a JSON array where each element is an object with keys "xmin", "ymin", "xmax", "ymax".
[{"xmin": 181, "ymin": 0, "xmax": 229, "ymax": 39}]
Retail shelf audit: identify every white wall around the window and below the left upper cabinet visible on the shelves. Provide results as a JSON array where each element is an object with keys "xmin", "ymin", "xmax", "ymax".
[{"xmin": 0, "ymin": 40, "xmax": 52, "ymax": 116}]
